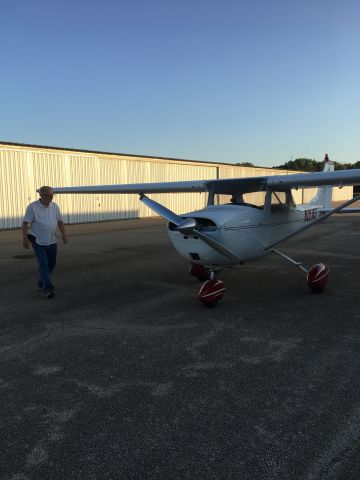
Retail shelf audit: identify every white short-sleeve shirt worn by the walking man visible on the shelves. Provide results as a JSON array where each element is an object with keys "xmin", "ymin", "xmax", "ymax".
[{"xmin": 24, "ymin": 200, "xmax": 62, "ymax": 245}]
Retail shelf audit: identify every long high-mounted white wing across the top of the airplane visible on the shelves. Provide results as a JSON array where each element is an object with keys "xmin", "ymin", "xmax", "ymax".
[{"xmin": 54, "ymin": 169, "xmax": 360, "ymax": 194}]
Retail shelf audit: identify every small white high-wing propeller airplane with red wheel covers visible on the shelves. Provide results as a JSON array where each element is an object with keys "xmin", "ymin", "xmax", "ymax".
[{"xmin": 54, "ymin": 155, "xmax": 360, "ymax": 307}]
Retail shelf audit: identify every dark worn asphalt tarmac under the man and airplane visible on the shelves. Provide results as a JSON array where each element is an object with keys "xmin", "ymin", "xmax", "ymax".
[{"xmin": 0, "ymin": 214, "xmax": 360, "ymax": 480}]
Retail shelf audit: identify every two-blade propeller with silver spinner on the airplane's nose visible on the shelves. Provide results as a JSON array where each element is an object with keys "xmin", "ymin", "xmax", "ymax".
[{"xmin": 140, "ymin": 194, "xmax": 241, "ymax": 263}]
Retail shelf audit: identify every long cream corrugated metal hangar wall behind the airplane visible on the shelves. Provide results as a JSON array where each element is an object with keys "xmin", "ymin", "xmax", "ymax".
[{"xmin": 0, "ymin": 144, "xmax": 352, "ymax": 229}]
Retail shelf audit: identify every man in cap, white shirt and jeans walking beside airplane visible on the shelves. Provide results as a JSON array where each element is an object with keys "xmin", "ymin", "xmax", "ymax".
[{"xmin": 22, "ymin": 186, "xmax": 68, "ymax": 298}]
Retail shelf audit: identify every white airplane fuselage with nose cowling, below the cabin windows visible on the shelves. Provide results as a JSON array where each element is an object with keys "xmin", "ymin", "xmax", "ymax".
[{"xmin": 168, "ymin": 204, "xmax": 319, "ymax": 266}]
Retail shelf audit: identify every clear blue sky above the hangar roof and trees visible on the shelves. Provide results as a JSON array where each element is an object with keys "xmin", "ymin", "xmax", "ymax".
[{"xmin": 0, "ymin": 0, "xmax": 360, "ymax": 166}]
